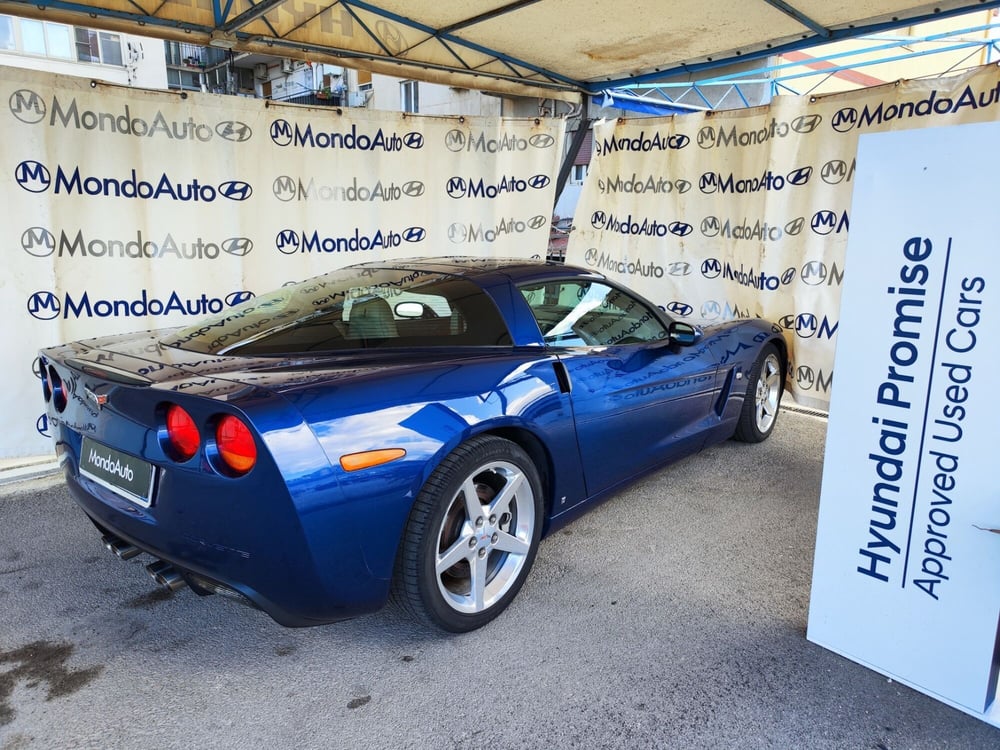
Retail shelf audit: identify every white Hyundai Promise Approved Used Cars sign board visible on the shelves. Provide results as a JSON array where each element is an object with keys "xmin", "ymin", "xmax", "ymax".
[{"xmin": 808, "ymin": 123, "xmax": 1000, "ymax": 726}]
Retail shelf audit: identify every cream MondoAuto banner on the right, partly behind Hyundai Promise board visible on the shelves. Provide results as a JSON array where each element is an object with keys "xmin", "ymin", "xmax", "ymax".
[{"xmin": 567, "ymin": 66, "xmax": 1000, "ymax": 408}]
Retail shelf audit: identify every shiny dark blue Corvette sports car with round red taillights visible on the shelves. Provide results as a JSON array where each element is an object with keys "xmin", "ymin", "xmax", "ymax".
[{"xmin": 38, "ymin": 258, "xmax": 787, "ymax": 632}]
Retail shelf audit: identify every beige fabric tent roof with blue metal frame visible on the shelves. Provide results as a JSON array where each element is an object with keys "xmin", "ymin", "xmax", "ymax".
[{"xmin": 0, "ymin": 0, "xmax": 1000, "ymax": 98}]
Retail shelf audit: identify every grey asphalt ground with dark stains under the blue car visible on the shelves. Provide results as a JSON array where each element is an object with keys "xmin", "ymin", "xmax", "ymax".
[{"xmin": 0, "ymin": 412, "xmax": 1000, "ymax": 750}]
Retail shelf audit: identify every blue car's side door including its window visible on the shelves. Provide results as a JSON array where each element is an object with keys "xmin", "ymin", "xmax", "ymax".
[{"xmin": 520, "ymin": 279, "xmax": 717, "ymax": 496}]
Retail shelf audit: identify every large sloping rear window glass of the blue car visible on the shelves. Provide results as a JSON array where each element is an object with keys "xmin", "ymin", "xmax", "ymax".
[{"xmin": 164, "ymin": 268, "xmax": 511, "ymax": 356}]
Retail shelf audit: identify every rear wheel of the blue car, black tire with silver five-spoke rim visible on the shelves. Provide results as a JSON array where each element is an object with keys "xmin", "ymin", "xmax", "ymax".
[{"xmin": 391, "ymin": 435, "xmax": 544, "ymax": 633}]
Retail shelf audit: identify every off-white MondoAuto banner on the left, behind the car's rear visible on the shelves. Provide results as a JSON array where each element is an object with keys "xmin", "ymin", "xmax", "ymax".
[{"xmin": 0, "ymin": 67, "xmax": 563, "ymax": 457}]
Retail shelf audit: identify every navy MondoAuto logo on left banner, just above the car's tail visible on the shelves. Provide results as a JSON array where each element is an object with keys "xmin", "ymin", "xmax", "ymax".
[{"xmin": 28, "ymin": 289, "xmax": 253, "ymax": 320}]
